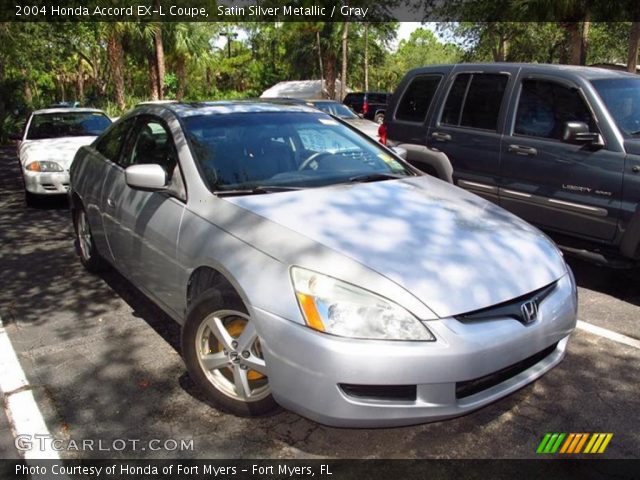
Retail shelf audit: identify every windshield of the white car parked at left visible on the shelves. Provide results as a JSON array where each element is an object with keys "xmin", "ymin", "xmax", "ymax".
[{"xmin": 27, "ymin": 112, "xmax": 111, "ymax": 140}]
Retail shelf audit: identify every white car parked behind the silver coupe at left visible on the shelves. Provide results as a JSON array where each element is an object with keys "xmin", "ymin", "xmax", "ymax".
[{"xmin": 18, "ymin": 108, "xmax": 111, "ymax": 206}]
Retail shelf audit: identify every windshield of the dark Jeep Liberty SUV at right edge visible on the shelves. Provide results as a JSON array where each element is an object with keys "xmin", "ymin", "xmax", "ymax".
[{"xmin": 591, "ymin": 78, "xmax": 640, "ymax": 137}]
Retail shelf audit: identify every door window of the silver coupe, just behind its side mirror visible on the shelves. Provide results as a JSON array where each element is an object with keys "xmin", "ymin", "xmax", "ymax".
[{"xmin": 122, "ymin": 117, "xmax": 178, "ymax": 180}]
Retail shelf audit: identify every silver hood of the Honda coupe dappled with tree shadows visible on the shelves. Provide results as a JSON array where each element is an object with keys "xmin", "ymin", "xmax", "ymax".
[{"xmin": 225, "ymin": 176, "xmax": 566, "ymax": 317}]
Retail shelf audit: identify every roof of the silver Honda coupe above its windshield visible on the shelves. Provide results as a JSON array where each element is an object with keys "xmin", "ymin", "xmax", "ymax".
[{"xmin": 136, "ymin": 100, "xmax": 319, "ymax": 118}]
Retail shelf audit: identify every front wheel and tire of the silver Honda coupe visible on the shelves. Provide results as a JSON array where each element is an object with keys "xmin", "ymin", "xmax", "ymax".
[{"xmin": 182, "ymin": 289, "xmax": 277, "ymax": 416}]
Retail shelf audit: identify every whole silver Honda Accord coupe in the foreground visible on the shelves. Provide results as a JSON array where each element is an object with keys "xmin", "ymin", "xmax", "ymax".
[{"xmin": 70, "ymin": 102, "xmax": 577, "ymax": 427}]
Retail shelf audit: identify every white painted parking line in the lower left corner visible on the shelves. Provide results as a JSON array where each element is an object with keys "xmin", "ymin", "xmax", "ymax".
[{"xmin": 0, "ymin": 318, "xmax": 60, "ymax": 463}]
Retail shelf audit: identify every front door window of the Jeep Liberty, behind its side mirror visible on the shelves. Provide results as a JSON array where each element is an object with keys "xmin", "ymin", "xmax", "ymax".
[{"xmin": 514, "ymin": 80, "xmax": 596, "ymax": 140}]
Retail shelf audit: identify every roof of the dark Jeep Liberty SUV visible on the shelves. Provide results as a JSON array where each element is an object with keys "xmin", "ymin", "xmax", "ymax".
[{"xmin": 411, "ymin": 62, "xmax": 638, "ymax": 80}]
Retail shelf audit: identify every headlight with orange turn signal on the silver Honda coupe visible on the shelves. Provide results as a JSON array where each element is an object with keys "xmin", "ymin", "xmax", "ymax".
[{"xmin": 291, "ymin": 267, "xmax": 435, "ymax": 342}]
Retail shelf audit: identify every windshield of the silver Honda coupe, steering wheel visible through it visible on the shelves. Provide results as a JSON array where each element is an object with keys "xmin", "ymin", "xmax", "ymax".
[{"xmin": 184, "ymin": 112, "xmax": 413, "ymax": 191}]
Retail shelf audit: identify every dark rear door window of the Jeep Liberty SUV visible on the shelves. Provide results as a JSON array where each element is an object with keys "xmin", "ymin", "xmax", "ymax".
[{"xmin": 440, "ymin": 73, "xmax": 509, "ymax": 130}]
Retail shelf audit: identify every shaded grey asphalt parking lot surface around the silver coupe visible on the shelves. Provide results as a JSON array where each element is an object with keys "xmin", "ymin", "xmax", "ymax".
[{"xmin": 0, "ymin": 148, "xmax": 640, "ymax": 458}]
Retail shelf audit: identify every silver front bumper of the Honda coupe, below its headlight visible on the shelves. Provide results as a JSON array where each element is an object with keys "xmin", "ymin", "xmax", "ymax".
[{"xmin": 253, "ymin": 274, "xmax": 577, "ymax": 427}]
